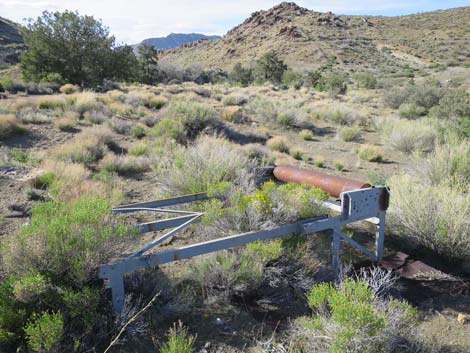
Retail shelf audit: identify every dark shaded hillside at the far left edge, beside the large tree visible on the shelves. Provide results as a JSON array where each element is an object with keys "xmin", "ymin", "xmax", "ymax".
[{"xmin": 0, "ymin": 17, "xmax": 24, "ymax": 65}]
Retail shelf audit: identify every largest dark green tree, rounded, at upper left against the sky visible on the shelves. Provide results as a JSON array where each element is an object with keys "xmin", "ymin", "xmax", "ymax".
[{"xmin": 20, "ymin": 11, "xmax": 137, "ymax": 86}]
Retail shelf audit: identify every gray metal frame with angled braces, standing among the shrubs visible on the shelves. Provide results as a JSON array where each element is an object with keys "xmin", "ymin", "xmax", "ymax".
[{"xmin": 99, "ymin": 187, "xmax": 388, "ymax": 315}]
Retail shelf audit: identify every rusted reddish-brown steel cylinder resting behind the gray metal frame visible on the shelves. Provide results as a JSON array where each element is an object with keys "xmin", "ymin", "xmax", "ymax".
[{"xmin": 274, "ymin": 166, "xmax": 371, "ymax": 197}]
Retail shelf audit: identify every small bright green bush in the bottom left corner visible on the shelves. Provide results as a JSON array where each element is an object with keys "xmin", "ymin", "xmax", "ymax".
[{"xmin": 25, "ymin": 312, "xmax": 64, "ymax": 352}]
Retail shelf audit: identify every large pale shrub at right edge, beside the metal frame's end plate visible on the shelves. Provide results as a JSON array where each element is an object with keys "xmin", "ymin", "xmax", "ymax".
[{"xmin": 388, "ymin": 175, "xmax": 470, "ymax": 259}]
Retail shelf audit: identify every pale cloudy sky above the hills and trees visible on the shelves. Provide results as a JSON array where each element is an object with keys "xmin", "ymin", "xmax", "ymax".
[{"xmin": 0, "ymin": 0, "xmax": 470, "ymax": 44}]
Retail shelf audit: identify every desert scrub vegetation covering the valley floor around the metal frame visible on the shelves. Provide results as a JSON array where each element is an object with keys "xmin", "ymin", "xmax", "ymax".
[{"xmin": 0, "ymin": 5, "xmax": 470, "ymax": 353}]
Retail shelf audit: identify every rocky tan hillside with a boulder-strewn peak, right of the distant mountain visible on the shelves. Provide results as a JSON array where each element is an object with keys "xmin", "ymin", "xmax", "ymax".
[{"xmin": 162, "ymin": 2, "xmax": 470, "ymax": 74}]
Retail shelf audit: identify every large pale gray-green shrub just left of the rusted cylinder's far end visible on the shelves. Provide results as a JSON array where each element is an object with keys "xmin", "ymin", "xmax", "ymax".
[{"xmin": 156, "ymin": 136, "xmax": 252, "ymax": 194}]
